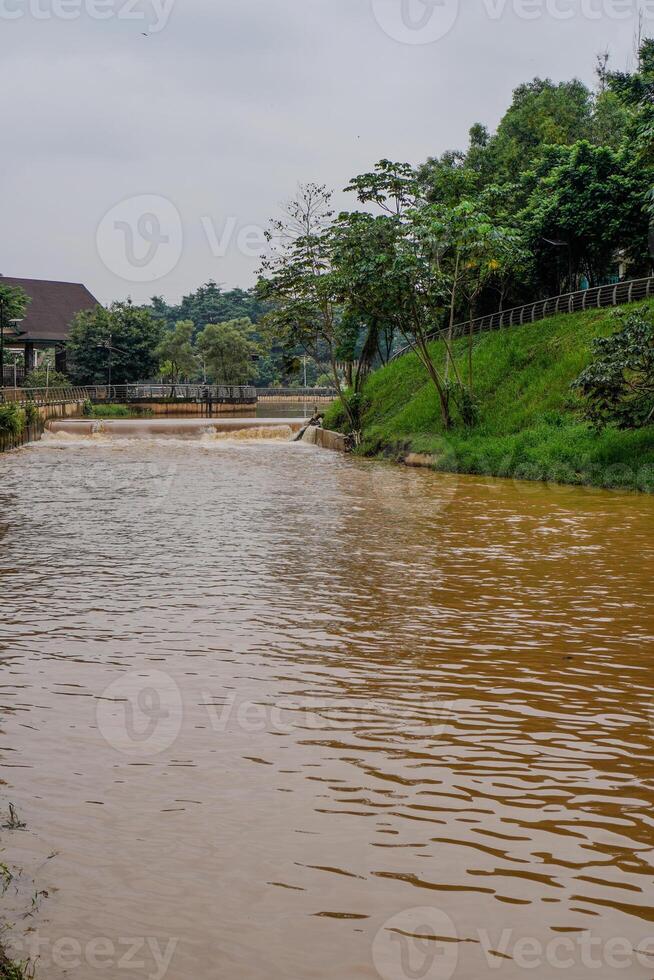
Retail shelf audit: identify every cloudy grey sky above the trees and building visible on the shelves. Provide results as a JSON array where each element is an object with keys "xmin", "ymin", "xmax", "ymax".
[{"xmin": 0, "ymin": 0, "xmax": 654, "ymax": 302}]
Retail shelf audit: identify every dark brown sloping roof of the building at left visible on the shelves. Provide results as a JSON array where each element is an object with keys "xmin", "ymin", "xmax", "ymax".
[{"xmin": 0, "ymin": 276, "xmax": 100, "ymax": 343}]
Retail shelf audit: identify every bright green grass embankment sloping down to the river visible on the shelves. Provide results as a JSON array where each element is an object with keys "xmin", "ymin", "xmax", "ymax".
[{"xmin": 325, "ymin": 301, "xmax": 654, "ymax": 492}]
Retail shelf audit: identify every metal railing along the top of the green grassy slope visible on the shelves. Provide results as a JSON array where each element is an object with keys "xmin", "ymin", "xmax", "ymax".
[{"xmin": 391, "ymin": 276, "xmax": 654, "ymax": 361}]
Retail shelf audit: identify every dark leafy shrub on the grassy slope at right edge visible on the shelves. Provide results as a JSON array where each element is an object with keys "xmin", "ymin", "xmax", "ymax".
[{"xmin": 572, "ymin": 310, "xmax": 654, "ymax": 429}]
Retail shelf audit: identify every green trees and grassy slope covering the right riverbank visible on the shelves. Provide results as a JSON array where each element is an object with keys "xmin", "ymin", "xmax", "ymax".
[{"xmin": 258, "ymin": 40, "xmax": 654, "ymax": 485}]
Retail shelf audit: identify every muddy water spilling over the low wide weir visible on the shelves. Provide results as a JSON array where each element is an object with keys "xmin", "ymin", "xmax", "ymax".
[{"xmin": 48, "ymin": 418, "xmax": 306, "ymax": 439}]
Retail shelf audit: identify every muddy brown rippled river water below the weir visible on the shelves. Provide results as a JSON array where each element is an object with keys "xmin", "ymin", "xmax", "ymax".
[{"xmin": 0, "ymin": 418, "xmax": 654, "ymax": 980}]
